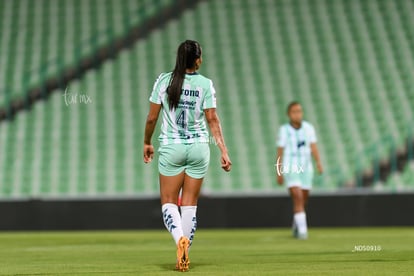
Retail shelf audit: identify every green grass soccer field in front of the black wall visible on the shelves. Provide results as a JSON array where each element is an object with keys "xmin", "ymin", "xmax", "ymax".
[{"xmin": 0, "ymin": 227, "xmax": 414, "ymax": 275}]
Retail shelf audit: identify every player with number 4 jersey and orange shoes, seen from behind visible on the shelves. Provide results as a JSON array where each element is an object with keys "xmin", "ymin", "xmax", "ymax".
[{"xmin": 144, "ymin": 40, "xmax": 231, "ymax": 271}]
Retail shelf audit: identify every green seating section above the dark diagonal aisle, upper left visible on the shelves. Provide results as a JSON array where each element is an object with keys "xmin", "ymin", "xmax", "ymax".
[{"xmin": 0, "ymin": 0, "xmax": 172, "ymax": 109}]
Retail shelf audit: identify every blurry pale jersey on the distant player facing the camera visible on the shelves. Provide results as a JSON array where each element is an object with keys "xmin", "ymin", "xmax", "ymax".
[{"xmin": 277, "ymin": 121, "xmax": 316, "ymax": 173}]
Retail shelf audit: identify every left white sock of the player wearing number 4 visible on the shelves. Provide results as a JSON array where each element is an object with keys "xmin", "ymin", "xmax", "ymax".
[{"xmin": 161, "ymin": 203, "xmax": 184, "ymax": 244}]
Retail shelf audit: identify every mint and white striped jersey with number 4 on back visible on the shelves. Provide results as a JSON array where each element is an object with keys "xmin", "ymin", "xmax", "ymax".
[{"xmin": 149, "ymin": 72, "xmax": 216, "ymax": 145}]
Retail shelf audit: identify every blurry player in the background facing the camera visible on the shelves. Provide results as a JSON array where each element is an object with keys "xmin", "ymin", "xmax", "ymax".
[{"xmin": 276, "ymin": 102, "xmax": 323, "ymax": 239}]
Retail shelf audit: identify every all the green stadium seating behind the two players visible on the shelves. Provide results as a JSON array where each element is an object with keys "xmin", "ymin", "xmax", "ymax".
[{"xmin": 0, "ymin": 0, "xmax": 414, "ymax": 198}]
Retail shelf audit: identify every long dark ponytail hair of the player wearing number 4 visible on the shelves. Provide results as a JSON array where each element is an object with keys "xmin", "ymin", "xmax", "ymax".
[{"xmin": 167, "ymin": 40, "xmax": 201, "ymax": 109}]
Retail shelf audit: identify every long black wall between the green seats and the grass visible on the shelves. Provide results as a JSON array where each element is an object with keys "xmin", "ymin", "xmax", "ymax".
[{"xmin": 0, "ymin": 193, "xmax": 414, "ymax": 231}]
